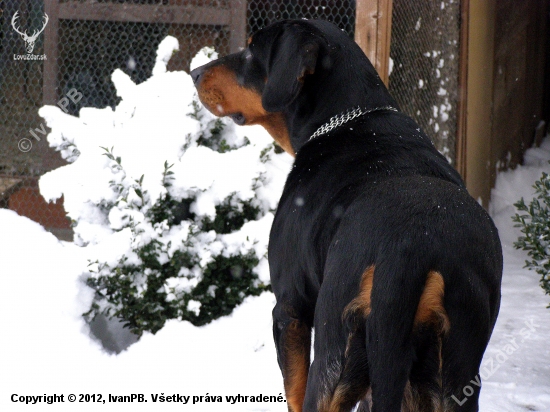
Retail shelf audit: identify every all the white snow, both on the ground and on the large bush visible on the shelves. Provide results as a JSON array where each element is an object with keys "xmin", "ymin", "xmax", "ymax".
[{"xmin": 0, "ymin": 40, "xmax": 550, "ymax": 412}]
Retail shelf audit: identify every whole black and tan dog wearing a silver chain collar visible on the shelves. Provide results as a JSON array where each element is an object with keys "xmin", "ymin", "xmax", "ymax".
[{"xmin": 191, "ymin": 20, "xmax": 502, "ymax": 412}]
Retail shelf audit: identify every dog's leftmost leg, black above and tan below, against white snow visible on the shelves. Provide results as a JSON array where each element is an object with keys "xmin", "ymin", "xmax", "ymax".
[{"xmin": 273, "ymin": 302, "xmax": 311, "ymax": 412}]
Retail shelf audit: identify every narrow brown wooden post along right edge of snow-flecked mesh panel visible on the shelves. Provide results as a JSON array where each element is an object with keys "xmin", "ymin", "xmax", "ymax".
[{"xmin": 456, "ymin": 0, "xmax": 470, "ymax": 180}]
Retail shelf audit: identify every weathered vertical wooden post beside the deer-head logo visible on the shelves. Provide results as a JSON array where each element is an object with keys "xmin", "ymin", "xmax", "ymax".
[{"xmin": 42, "ymin": 0, "xmax": 59, "ymax": 104}]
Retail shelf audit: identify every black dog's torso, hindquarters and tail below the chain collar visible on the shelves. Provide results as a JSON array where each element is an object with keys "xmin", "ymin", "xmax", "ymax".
[{"xmin": 269, "ymin": 108, "xmax": 502, "ymax": 411}]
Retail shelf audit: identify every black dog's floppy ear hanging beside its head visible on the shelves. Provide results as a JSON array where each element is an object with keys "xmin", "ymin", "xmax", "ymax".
[{"xmin": 262, "ymin": 28, "xmax": 320, "ymax": 112}]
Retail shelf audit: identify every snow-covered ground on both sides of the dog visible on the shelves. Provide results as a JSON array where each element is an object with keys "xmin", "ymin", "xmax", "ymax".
[{"xmin": 0, "ymin": 140, "xmax": 550, "ymax": 412}]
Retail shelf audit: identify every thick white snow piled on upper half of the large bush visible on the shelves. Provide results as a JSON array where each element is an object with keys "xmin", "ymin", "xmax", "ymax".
[{"xmin": 39, "ymin": 37, "xmax": 290, "ymax": 244}]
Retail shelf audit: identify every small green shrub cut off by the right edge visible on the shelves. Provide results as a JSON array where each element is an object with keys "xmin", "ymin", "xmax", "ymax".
[{"xmin": 512, "ymin": 163, "xmax": 550, "ymax": 307}]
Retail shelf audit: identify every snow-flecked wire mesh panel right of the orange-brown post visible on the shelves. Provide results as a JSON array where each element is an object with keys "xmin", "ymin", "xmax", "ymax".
[{"xmin": 389, "ymin": 0, "xmax": 460, "ymax": 164}]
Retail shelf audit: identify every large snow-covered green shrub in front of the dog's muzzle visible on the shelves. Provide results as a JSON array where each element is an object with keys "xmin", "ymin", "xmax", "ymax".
[{"xmin": 40, "ymin": 37, "xmax": 290, "ymax": 335}]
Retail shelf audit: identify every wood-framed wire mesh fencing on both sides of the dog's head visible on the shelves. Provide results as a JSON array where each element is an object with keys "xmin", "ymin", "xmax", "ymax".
[{"xmin": 0, "ymin": 0, "xmax": 459, "ymax": 237}]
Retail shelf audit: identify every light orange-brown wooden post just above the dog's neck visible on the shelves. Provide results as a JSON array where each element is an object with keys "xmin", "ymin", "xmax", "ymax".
[{"xmin": 355, "ymin": 0, "xmax": 393, "ymax": 85}]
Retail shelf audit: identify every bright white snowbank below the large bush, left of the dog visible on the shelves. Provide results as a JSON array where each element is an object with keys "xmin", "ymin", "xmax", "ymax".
[{"xmin": 0, "ymin": 209, "xmax": 285, "ymax": 411}]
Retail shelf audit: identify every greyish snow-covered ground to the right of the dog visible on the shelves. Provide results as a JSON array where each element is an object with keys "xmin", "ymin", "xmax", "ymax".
[{"xmin": 481, "ymin": 138, "xmax": 550, "ymax": 412}]
